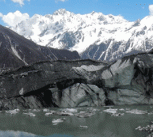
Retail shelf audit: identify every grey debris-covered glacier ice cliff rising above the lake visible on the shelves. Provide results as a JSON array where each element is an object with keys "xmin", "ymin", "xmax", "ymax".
[{"xmin": 0, "ymin": 52, "xmax": 153, "ymax": 109}]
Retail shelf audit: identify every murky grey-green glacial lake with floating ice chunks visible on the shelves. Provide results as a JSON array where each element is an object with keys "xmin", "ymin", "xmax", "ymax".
[{"xmin": 0, "ymin": 106, "xmax": 153, "ymax": 137}]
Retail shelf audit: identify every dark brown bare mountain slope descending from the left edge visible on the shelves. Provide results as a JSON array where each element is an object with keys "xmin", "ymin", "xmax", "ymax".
[{"xmin": 0, "ymin": 25, "xmax": 80, "ymax": 70}]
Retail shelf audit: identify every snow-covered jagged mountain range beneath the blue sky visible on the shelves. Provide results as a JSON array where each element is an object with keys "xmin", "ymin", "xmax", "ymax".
[{"xmin": 11, "ymin": 9, "xmax": 153, "ymax": 60}]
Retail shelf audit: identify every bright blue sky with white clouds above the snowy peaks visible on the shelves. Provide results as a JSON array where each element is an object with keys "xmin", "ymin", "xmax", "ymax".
[{"xmin": 0, "ymin": 0, "xmax": 153, "ymax": 26}]
